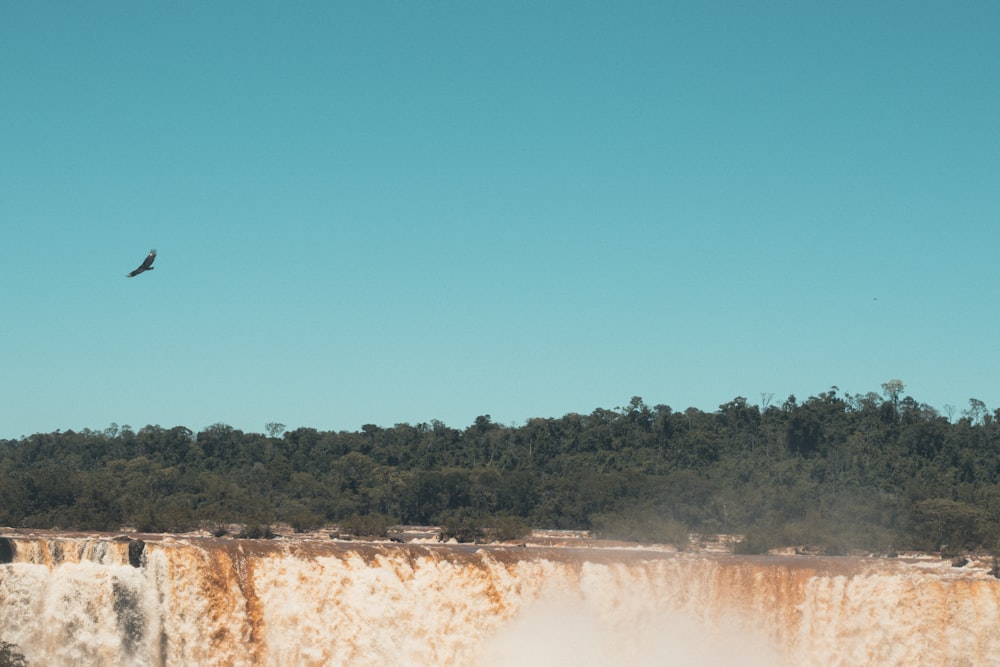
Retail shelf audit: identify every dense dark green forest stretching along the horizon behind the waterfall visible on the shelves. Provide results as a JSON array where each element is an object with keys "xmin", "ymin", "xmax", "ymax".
[{"xmin": 0, "ymin": 380, "xmax": 1000, "ymax": 553}]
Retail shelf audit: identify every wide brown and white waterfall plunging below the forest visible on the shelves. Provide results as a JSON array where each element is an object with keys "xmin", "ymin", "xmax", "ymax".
[{"xmin": 0, "ymin": 534, "xmax": 1000, "ymax": 667}]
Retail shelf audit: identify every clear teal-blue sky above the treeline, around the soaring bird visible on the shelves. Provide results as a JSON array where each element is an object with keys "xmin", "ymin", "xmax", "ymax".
[{"xmin": 0, "ymin": 0, "xmax": 1000, "ymax": 437}]
